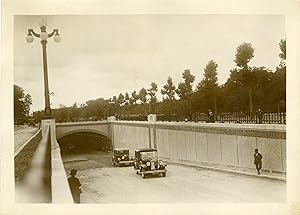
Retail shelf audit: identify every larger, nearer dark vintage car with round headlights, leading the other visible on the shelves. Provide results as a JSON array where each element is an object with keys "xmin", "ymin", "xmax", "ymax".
[{"xmin": 134, "ymin": 148, "xmax": 167, "ymax": 178}]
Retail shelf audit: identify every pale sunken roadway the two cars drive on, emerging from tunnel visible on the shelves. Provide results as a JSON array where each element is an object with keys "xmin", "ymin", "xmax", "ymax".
[{"xmin": 63, "ymin": 152, "xmax": 286, "ymax": 203}]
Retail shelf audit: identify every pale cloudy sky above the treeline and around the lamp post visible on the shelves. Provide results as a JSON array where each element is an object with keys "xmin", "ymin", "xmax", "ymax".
[{"xmin": 14, "ymin": 15, "xmax": 285, "ymax": 111}]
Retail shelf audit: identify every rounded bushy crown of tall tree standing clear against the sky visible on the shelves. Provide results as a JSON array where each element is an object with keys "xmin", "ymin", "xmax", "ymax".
[{"xmin": 234, "ymin": 43, "xmax": 254, "ymax": 69}]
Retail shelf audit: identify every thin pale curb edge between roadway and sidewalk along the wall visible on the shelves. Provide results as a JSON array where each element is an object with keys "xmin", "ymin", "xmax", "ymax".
[{"xmin": 168, "ymin": 161, "xmax": 286, "ymax": 182}]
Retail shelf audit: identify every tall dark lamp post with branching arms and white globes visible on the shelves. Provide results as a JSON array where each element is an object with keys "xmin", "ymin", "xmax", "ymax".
[{"xmin": 26, "ymin": 19, "xmax": 61, "ymax": 119}]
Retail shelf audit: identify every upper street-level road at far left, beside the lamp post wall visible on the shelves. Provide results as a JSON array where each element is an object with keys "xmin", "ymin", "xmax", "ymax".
[{"xmin": 14, "ymin": 126, "xmax": 38, "ymax": 155}]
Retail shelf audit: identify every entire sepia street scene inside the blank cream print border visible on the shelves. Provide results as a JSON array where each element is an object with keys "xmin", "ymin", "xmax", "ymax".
[{"xmin": 13, "ymin": 14, "xmax": 288, "ymax": 204}]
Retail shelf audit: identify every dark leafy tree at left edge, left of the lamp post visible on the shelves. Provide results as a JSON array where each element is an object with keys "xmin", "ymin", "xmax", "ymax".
[{"xmin": 14, "ymin": 84, "xmax": 32, "ymax": 123}]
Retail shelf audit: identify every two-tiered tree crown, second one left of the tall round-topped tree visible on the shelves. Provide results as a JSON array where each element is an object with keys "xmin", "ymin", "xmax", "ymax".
[{"xmin": 176, "ymin": 69, "xmax": 195, "ymax": 99}]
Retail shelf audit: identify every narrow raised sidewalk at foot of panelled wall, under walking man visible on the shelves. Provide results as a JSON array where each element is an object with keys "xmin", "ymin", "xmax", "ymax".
[{"xmin": 162, "ymin": 158, "xmax": 286, "ymax": 182}]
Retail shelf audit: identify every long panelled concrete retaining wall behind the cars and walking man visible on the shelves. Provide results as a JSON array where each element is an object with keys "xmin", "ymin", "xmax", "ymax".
[{"xmin": 112, "ymin": 121, "xmax": 286, "ymax": 172}]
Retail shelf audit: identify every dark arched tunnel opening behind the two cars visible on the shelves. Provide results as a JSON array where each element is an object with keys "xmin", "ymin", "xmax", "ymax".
[{"xmin": 57, "ymin": 131, "xmax": 112, "ymax": 155}]
